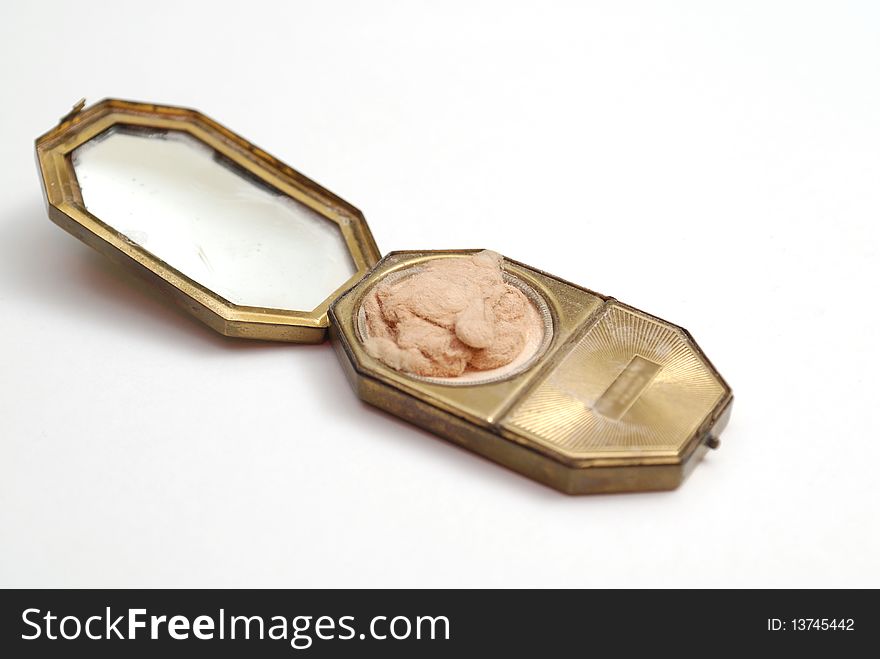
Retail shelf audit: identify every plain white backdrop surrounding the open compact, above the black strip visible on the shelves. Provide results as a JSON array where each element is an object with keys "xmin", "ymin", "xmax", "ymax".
[{"xmin": 0, "ymin": 0, "xmax": 880, "ymax": 587}]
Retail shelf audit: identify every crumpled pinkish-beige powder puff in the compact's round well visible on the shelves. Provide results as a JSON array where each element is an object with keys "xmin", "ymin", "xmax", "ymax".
[{"xmin": 362, "ymin": 251, "xmax": 545, "ymax": 378}]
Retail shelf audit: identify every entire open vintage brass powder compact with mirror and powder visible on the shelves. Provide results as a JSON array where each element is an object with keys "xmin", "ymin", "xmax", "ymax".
[{"xmin": 36, "ymin": 99, "xmax": 733, "ymax": 494}]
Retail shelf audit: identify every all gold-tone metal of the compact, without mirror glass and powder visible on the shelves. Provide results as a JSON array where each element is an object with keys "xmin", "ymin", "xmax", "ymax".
[{"xmin": 36, "ymin": 99, "xmax": 733, "ymax": 494}]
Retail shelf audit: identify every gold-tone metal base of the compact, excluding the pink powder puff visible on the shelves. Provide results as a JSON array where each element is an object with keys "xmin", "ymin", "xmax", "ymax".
[{"xmin": 330, "ymin": 250, "xmax": 733, "ymax": 494}]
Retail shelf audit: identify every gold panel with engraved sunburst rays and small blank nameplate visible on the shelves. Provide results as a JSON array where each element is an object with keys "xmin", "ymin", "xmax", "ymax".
[{"xmin": 503, "ymin": 304, "xmax": 725, "ymax": 459}]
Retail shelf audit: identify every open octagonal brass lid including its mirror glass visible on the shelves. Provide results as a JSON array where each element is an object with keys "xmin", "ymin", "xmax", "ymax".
[{"xmin": 36, "ymin": 99, "xmax": 379, "ymax": 343}]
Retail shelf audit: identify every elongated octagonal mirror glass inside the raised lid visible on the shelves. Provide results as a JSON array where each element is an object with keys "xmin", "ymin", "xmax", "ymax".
[{"xmin": 72, "ymin": 128, "xmax": 356, "ymax": 311}]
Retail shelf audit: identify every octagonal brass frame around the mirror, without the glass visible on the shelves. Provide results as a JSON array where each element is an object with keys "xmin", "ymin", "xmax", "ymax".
[{"xmin": 36, "ymin": 99, "xmax": 380, "ymax": 343}]
